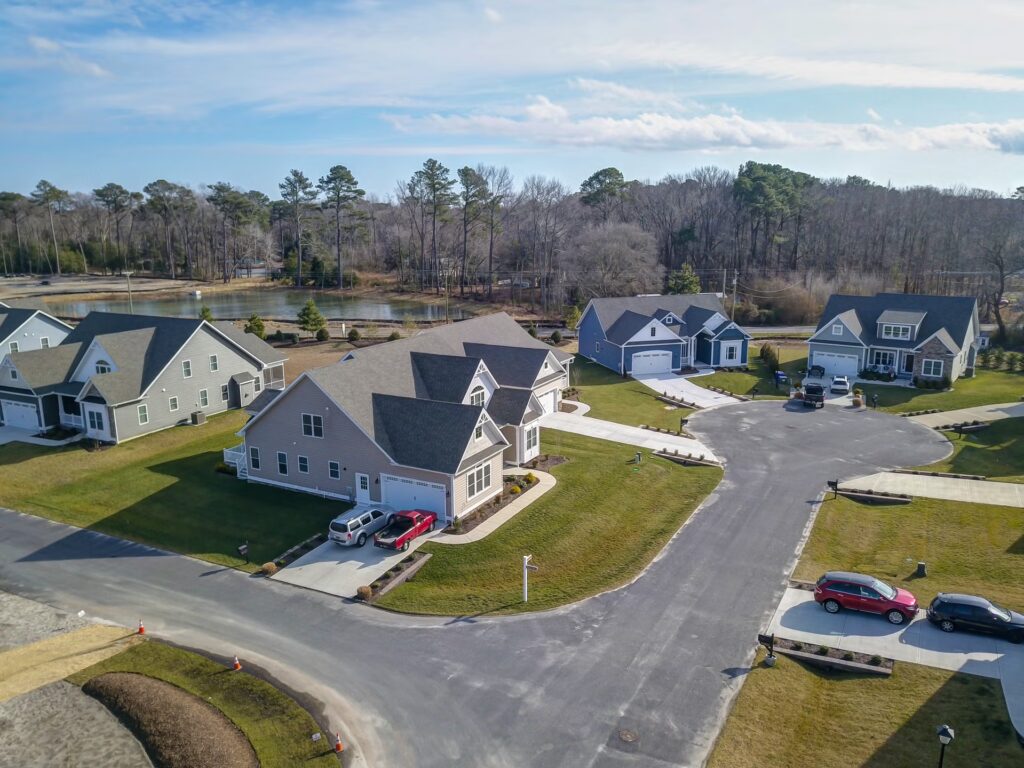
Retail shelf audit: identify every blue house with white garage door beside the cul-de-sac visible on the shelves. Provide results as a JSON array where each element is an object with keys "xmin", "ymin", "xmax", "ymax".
[{"xmin": 579, "ymin": 293, "xmax": 751, "ymax": 375}]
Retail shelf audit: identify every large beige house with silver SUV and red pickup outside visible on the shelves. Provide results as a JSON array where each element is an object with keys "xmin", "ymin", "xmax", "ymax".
[{"xmin": 225, "ymin": 313, "xmax": 571, "ymax": 522}]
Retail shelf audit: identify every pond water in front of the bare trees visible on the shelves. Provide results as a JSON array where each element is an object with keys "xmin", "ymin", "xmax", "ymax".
[{"xmin": 47, "ymin": 289, "xmax": 470, "ymax": 323}]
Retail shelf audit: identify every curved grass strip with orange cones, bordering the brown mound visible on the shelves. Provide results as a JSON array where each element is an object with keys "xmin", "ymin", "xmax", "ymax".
[{"xmin": 69, "ymin": 640, "xmax": 338, "ymax": 768}]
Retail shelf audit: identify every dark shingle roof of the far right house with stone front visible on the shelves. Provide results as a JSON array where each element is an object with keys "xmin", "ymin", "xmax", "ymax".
[{"xmin": 817, "ymin": 293, "xmax": 978, "ymax": 350}]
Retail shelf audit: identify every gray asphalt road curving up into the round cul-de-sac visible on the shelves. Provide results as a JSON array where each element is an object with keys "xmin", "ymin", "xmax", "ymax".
[{"xmin": 0, "ymin": 401, "xmax": 948, "ymax": 768}]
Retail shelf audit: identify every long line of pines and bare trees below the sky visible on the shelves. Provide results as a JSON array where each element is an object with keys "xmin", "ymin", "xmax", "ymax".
[{"xmin": 0, "ymin": 159, "xmax": 1024, "ymax": 326}]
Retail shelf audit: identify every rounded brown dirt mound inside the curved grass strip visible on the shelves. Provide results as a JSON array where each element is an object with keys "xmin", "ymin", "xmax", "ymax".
[{"xmin": 82, "ymin": 672, "xmax": 259, "ymax": 768}]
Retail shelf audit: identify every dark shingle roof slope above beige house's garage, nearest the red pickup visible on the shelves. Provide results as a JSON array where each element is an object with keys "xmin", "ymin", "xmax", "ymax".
[{"xmin": 373, "ymin": 394, "xmax": 487, "ymax": 474}]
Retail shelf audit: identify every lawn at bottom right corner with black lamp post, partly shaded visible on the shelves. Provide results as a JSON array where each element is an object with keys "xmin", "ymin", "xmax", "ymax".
[{"xmin": 708, "ymin": 652, "xmax": 1024, "ymax": 768}]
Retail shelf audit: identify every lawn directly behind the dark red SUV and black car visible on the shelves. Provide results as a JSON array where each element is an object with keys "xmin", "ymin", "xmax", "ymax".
[{"xmin": 794, "ymin": 497, "xmax": 1024, "ymax": 610}]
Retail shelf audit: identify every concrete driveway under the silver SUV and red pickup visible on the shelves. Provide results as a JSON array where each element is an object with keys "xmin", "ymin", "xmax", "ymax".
[{"xmin": 271, "ymin": 528, "xmax": 440, "ymax": 597}]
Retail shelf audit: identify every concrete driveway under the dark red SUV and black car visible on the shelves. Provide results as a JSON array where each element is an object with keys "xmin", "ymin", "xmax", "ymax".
[{"xmin": 768, "ymin": 589, "xmax": 1024, "ymax": 735}]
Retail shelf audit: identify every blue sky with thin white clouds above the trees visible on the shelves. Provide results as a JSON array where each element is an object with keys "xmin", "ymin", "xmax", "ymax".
[{"xmin": 0, "ymin": 0, "xmax": 1024, "ymax": 197}]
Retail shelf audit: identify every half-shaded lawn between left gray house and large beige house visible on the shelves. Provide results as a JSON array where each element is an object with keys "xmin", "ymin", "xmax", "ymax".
[{"xmin": 0, "ymin": 412, "xmax": 346, "ymax": 569}]
